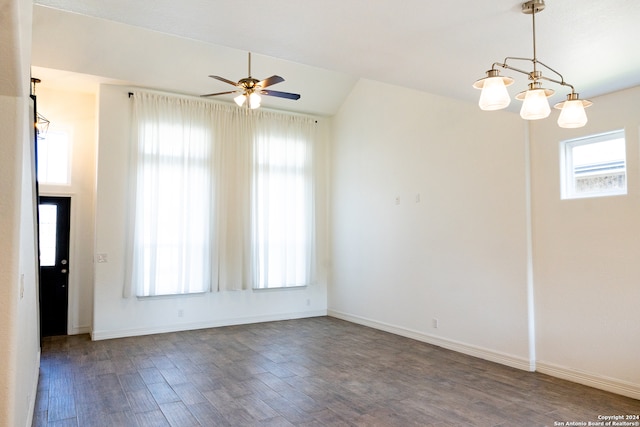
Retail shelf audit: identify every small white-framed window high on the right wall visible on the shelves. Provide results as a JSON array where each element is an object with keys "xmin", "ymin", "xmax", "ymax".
[{"xmin": 560, "ymin": 130, "xmax": 627, "ymax": 199}]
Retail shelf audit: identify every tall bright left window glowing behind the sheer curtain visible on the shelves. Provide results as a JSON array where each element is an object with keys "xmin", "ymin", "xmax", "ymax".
[{"xmin": 130, "ymin": 123, "xmax": 212, "ymax": 296}]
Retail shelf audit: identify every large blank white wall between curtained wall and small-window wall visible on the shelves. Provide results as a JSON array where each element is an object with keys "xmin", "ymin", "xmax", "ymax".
[{"xmin": 329, "ymin": 81, "xmax": 533, "ymax": 369}]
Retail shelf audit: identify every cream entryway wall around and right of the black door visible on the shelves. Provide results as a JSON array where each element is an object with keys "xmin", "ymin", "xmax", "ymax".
[{"xmin": 36, "ymin": 88, "xmax": 97, "ymax": 335}]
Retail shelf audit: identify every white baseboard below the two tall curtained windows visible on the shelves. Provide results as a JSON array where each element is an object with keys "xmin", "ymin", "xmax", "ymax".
[{"xmin": 91, "ymin": 310, "xmax": 327, "ymax": 341}]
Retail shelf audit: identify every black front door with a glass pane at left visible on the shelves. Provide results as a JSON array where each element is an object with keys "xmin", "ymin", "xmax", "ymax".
[{"xmin": 38, "ymin": 196, "xmax": 71, "ymax": 337}]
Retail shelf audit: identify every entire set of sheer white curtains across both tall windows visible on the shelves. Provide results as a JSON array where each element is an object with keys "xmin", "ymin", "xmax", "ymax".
[{"xmin": 125, "ymin": 92, "xmax": 315, "ymax": 296}]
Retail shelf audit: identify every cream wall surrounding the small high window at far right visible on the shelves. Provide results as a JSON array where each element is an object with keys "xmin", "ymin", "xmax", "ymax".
[{"xmin": 531, "ymin": 88, "xmax": 640, "ymax": 398}]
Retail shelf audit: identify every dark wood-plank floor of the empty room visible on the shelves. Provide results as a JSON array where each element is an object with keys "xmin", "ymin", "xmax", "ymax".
[{"xmin": 33, "ymin": 317, "xmax": 640, "ymax": 427}]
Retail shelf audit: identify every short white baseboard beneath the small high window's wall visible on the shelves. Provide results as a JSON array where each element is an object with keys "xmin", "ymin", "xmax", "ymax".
[{"xmin": 537, "ymin": 361, "xmax": 640, "ymax": 399}]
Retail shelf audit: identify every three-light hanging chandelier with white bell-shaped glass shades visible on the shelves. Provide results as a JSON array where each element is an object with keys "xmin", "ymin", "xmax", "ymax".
[{"xmin": 473, "ymin": 0, "xmax": 592, "ymax": 128}]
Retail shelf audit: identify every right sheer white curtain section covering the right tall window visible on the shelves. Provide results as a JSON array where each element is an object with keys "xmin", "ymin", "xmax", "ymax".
[{"xmin": 251, "ymin": 113, "xmax": 317, "ymax": 288}]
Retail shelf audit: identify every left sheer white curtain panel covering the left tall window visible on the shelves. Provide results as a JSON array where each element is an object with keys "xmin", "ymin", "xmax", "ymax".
[{"xmin": 130, "ymin": 93, "xmax": 218, "ymax": 296}]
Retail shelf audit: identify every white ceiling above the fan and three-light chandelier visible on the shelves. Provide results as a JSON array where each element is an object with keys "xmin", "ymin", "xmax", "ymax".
[{"xmin": 34, "ymin": 0, "xmax": 640, "ymax": 114}]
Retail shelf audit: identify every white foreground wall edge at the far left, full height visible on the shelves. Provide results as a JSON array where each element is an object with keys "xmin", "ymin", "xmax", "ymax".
[{"xmin": 0, "ymin": 0, "xmax": 40, "ymax": 426}]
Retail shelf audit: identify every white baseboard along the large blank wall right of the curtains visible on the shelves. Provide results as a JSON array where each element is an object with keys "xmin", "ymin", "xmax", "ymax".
[{"xmin": 327, "ymin": 310, "xmax": 535, "ymax": 372}]
